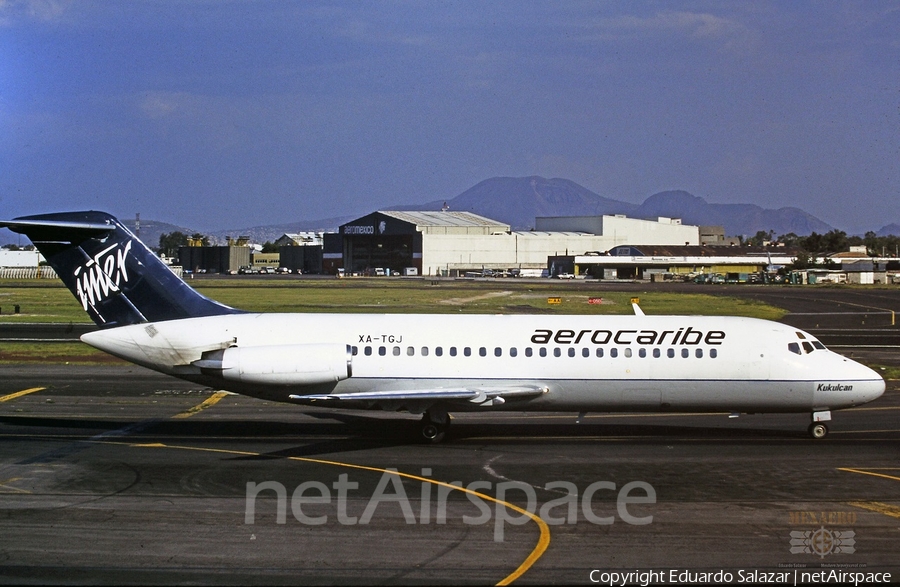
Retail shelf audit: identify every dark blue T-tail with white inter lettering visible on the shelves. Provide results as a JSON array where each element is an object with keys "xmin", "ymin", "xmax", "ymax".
[{"xmin": 0, "ymin": 211, "xmax": 240, "ymax": 328}]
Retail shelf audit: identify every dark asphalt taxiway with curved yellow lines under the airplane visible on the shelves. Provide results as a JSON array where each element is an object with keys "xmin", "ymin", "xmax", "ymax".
[{"xmin": 0, "ymin": 290, "xmax": 900, "ymax": 584}]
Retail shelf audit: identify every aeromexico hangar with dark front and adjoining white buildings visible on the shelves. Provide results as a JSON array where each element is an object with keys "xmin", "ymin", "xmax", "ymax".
[{"xmin": 322, "ymin": 210, "xmax": 700, "ymax": 276}]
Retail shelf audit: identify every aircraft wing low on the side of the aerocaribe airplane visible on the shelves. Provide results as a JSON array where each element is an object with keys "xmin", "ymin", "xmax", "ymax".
[{"xmin": 290, "ymin": 385, "xmax": 548, "ymax": 407}]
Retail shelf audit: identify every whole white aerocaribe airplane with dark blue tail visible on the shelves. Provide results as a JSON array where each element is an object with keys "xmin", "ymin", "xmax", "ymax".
[{"xmin": 0, "ymin": 212, "xmax": 885, "ymax": 442}]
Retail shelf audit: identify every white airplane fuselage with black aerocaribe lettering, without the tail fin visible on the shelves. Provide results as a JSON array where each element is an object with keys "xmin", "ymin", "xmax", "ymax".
[{"xmin": 83, "ymin": 314, "xmax": 884, "ymax": 412}]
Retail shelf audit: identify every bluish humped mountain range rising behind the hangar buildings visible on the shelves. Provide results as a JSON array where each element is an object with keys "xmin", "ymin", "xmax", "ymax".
[{"xmin": 396, "ymin": 176, "xmax": 832, "ymax": 236}]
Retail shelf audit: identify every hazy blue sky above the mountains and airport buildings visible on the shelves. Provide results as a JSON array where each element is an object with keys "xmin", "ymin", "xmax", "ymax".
[{"xmin": 0, "ymin": 0, "xmax": 900, "ymax": 233}]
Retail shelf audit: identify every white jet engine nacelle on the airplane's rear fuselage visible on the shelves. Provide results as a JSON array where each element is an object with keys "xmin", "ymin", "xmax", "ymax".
[{"xmin": 192, "ymin": 344, "xmax": 353, "ymax": 386}]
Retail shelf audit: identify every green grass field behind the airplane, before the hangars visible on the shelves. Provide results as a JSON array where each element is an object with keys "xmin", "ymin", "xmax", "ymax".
[{"xmin": 0, "ymin": 278, "xmax": 784, "ymax": 364}]
